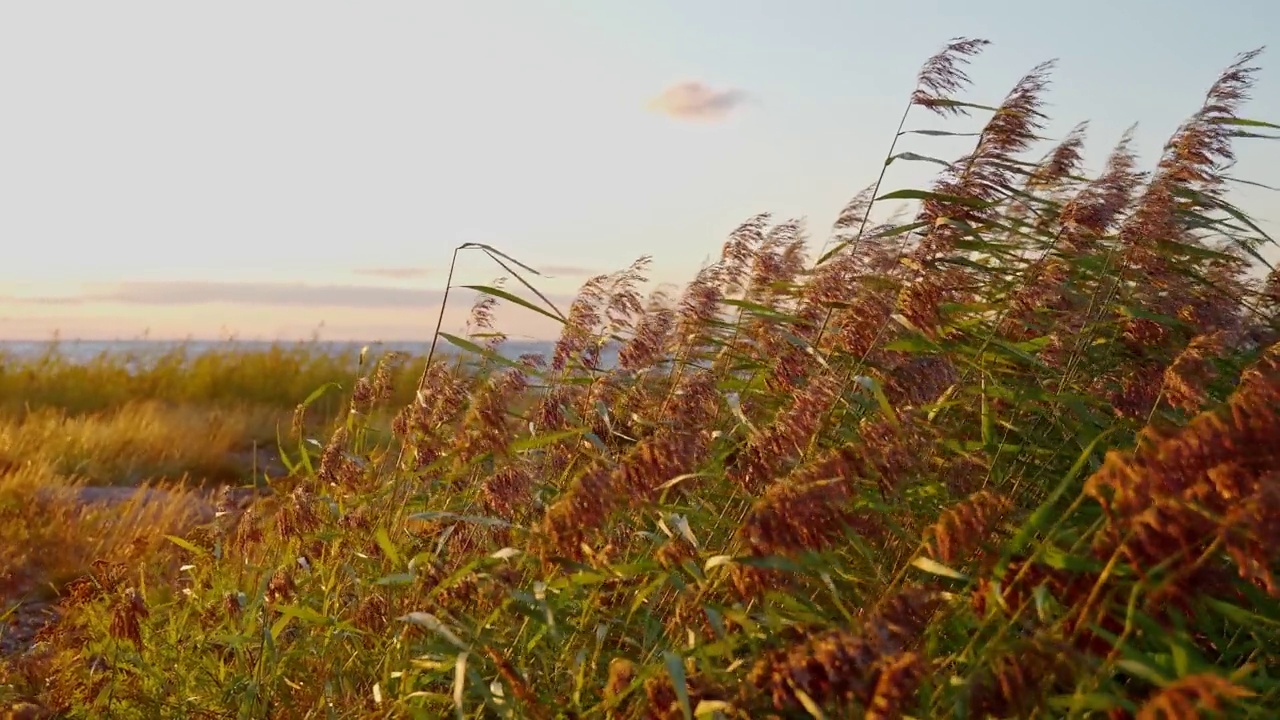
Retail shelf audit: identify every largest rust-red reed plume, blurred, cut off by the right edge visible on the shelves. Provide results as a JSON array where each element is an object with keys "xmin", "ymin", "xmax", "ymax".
[{"xmin": 1085, "ymin": 345, "xmax": 1280, "ymax": 596}]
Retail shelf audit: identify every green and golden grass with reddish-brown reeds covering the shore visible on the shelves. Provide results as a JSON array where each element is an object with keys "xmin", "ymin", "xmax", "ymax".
[{"xmin": 0, "ymin": 38, "xmax": 1280, "ymax": 719}]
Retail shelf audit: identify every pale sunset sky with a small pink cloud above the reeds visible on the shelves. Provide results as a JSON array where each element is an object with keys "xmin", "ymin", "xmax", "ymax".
[{"xmin": 0, "ymin": 0, "xmax": 1280, "ymax": 341}]
